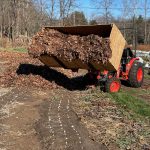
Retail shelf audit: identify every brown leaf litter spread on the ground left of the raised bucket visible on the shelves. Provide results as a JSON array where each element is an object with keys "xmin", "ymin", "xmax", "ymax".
[{"xmin": 0, "ymin": 52, "xmax": 72, "ymax": 89}]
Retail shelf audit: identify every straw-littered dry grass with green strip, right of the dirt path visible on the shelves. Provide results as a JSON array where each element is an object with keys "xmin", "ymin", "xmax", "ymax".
[{"xmin": 74, "ymin": 90, "xmax": 150, "ymax": 150}]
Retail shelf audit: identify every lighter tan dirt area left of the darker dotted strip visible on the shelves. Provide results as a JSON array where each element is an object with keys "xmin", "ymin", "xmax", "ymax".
[{"xmin": 0, "ymin": 88, "xmax": 42, "ymax": 150}]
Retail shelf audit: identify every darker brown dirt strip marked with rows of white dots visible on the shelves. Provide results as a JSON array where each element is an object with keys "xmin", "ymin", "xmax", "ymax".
[{"xmin": 36, "ymin": 90, "xmax": 106, "ymax": 150}]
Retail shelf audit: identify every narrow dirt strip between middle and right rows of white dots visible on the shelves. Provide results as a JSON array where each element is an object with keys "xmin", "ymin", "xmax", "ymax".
[{"xmin": 52, "ymin": 96, "xmax": 83, "ymax": 149}]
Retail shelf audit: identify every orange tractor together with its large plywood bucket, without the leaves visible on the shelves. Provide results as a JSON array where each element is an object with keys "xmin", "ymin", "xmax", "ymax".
[{"xmin": 32, "ymin": 24, "xmax": 144, "ymax": 92}]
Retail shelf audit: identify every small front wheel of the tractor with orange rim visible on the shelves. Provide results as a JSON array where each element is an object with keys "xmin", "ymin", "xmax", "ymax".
[{"xmin": 105, "ymin": 77, "xmax": 121, "ymax": 93}]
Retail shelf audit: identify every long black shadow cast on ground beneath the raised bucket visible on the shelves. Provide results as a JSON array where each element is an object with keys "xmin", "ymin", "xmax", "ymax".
[{"xmin": 16, "ymin": 64, "xmax": 95, "ymax": 90}]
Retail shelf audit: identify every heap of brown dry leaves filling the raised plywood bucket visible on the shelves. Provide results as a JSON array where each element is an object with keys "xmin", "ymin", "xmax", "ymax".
[{"xmin": 28, "ymin": 29, "xmax": 112, "ymax": 64}]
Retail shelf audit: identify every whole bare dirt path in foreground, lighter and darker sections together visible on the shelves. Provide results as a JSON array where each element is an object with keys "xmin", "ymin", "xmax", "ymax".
[{"xmin": 0, "ymin": 88, "xmax": 106, "ymax": 150}]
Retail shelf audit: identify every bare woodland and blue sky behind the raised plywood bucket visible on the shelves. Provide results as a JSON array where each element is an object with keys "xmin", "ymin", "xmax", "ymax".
[{"xmin": 0, "ymin": 0, "xmax": 150, "ymax": 47}]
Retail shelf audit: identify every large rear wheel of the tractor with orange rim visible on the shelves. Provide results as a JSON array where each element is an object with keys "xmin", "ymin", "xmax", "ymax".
[{"xmin": 128, "ymin": 62, "xmax": 144, "ymax": 88}]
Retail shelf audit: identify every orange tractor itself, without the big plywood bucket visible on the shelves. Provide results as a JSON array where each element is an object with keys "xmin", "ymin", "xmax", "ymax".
[{"xmin": 89, "ymin": 48, "xmax": 144, "ymax": 93}]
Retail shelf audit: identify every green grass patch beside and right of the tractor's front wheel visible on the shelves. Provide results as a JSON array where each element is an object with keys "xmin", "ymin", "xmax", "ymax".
[{"xmin": 109, "ymin": 92, "xmax": 150, "ymax": 118}]
